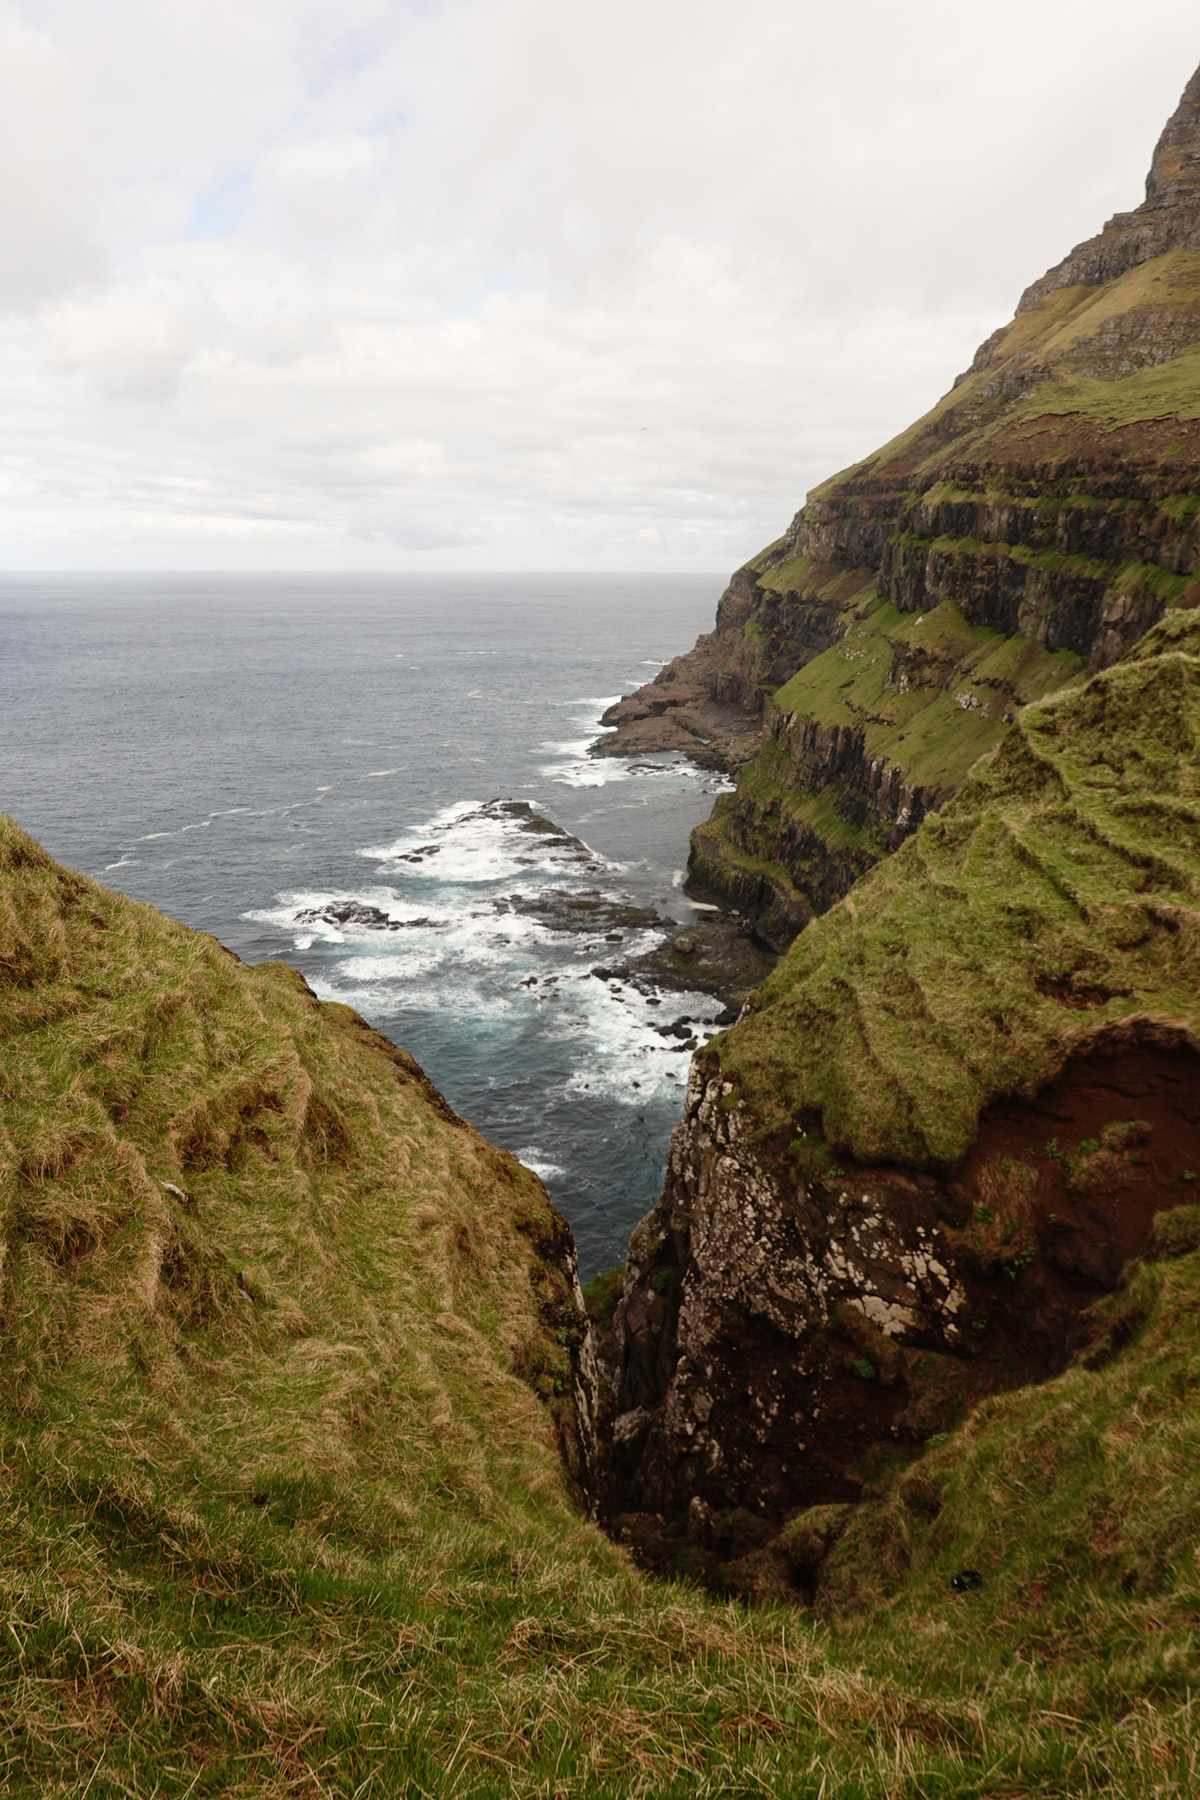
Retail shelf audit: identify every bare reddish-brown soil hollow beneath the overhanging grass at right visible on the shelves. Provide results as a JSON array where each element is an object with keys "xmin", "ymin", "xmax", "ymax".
[{"xmin": 804, "ymin": 1028, "xmax": 1200, "ymax": 1503}]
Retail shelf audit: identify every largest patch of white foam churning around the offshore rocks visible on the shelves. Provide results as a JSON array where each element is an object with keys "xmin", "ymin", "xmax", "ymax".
[{"xmin": 246, "ymin": 784, "xmax": 721, "ymax": 1108}]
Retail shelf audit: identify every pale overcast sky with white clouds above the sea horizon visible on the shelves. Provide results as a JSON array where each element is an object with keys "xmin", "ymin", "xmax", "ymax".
[{"xmin": 0, "ymin": 0, "xmax": 1200, "ymax": 571}]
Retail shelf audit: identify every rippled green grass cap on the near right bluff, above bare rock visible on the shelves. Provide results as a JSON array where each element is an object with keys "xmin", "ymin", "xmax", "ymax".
[{"xmin": 714, "ymin": 612, "xmax": 1200, "ymax": 1166}]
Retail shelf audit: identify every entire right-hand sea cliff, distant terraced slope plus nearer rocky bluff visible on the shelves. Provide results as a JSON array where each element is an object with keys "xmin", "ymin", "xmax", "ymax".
[{"xmin": 604, "ymin": 63, "xmax": 1200, "ymax": 1606}]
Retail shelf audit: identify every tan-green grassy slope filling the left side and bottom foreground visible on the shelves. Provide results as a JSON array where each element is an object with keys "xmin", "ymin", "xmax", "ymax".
[{"xmin": 0, "ymin": 821, "xmax": 1195, "ymax": 1800}]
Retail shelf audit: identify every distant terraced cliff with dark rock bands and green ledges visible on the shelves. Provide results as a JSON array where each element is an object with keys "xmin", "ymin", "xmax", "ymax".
[{"xmin": 599, "ymin": 63, "xmax": 1200, "ymax": 949}]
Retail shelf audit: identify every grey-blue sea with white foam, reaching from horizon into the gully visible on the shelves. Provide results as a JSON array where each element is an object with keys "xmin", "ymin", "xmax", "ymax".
[{"xmin": 0, "ymin": 574, "xmax": 723, "ymax": 1280}]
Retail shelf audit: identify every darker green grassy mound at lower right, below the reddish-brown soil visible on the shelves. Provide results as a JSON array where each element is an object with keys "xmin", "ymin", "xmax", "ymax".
[{"xmin": 822, "ymin": 1238, "xmax": 1200, "ymax": 1699}]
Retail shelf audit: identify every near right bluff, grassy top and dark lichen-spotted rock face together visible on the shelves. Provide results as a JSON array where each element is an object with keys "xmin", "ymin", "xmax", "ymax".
[{"xmin": 610, "ymin": 612, "xmax": 1200, "ymax": 1588}]
